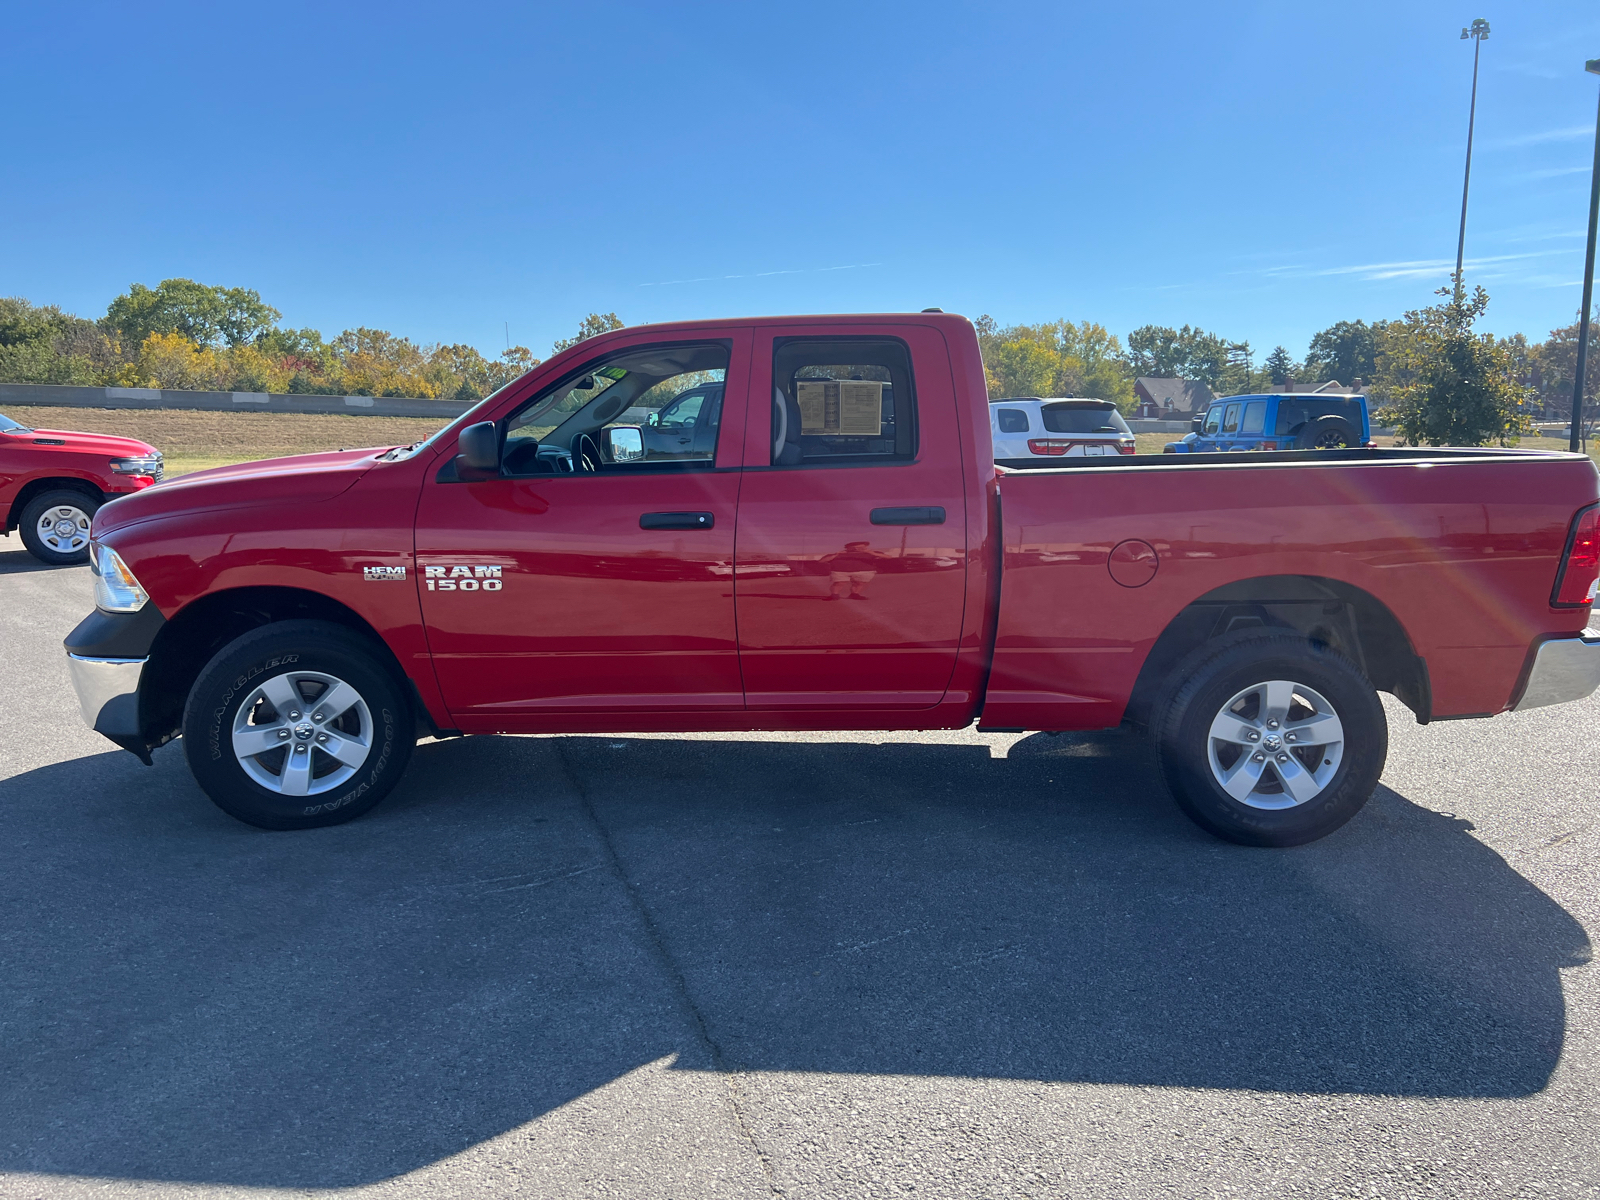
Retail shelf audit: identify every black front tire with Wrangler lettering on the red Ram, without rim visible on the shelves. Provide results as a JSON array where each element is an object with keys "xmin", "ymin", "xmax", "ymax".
[{"xmin": 184, "ymin": 621, "xmax": 414, "ymax": 830}]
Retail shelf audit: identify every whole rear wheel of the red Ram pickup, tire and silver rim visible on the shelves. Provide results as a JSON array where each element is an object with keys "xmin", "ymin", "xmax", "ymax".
[{"xmin": 1152, "ymin": 632, "xmax": 1389, "ymax": 846}]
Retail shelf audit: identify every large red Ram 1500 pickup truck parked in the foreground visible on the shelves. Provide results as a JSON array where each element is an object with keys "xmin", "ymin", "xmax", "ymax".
[{"xmin": 66, "ymin": 312, "xmax": 1600, "ymax": 845}]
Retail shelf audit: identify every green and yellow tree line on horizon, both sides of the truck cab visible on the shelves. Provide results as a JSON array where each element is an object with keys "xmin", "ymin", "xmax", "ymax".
[{"xmin": 0, "ymin": 278, "xmax": 1600, "ymax": 445}]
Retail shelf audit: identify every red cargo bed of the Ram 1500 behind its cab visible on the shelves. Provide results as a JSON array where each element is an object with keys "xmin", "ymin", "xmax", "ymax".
[{"xmin": 984, "ymin": 448, "xmax": 1597, "ymax": 730}]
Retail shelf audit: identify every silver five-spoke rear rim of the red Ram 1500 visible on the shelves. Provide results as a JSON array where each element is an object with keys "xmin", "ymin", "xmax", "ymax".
[{"xmin": 1206, "ymin": 678, "xmax": 1344, "ymax": 810}]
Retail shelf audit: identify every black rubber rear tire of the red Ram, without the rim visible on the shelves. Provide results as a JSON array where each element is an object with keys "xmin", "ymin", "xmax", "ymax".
[{"xmin": 1154, "ymin": 634, "xmax": 1389, "ymax": 846}]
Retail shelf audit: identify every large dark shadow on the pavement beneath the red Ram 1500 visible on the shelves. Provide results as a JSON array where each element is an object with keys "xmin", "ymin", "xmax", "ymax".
[{"xmin": 0, "ymin": 733, "xmax": 1589, "ymax": 1187}]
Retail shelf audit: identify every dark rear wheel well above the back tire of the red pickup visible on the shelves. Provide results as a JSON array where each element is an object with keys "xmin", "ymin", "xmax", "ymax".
[{"xmin": 1128, "ymin": 574, "xmax": 1432, "ymax": 725}]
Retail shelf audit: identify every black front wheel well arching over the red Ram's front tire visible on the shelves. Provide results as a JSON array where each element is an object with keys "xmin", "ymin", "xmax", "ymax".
[{"xmin": 139, "ymin": 587, "xmax": 429, "ymax": 747}]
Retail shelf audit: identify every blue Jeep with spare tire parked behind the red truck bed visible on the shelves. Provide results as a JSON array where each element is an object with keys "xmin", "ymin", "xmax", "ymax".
[{"xmin": 1166, "ymin": 392, "xmax": 1373, "ymax": 454}]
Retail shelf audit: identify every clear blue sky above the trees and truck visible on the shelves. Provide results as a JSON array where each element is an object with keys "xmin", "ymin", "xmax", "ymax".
[{"xmin": 9, "ymin": 0, "xmax": 1600, "ymax": 362}]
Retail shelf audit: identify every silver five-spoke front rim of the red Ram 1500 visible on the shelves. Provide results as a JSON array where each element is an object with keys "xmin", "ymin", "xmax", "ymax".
[{"xmin": 232, "ymin": 670, "xmax": 373, "ymax": 798}]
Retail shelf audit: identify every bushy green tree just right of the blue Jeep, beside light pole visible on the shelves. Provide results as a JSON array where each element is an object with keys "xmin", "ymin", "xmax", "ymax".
[{"xmin": 1374, "ymin": 288, "xmax": 1533, "ymax": 446}]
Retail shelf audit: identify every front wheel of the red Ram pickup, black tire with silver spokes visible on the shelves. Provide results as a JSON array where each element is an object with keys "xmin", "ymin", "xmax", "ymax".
[{"xmin": 184, "ymin": 621, "xmax": 416, "ymax": 829}]
